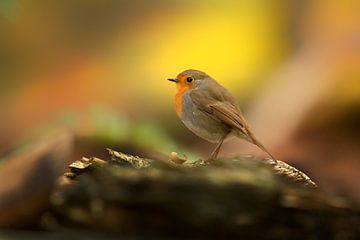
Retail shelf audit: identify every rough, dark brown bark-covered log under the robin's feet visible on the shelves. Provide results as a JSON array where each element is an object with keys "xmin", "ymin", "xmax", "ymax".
[{"xmin": 43, "ymin": 150, "xmax": 360, "ymax": 239}]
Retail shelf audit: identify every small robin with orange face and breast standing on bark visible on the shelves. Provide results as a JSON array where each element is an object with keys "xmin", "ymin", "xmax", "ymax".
[{"xmin": 168, "ymin": 69, "xmax": 276, "ymax": 161}]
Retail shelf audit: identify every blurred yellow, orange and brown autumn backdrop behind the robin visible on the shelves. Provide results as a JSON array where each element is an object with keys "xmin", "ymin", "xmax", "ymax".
[{"xmin": 0, "ymin": 0, "xmax": 360, "ymax": 199}]
